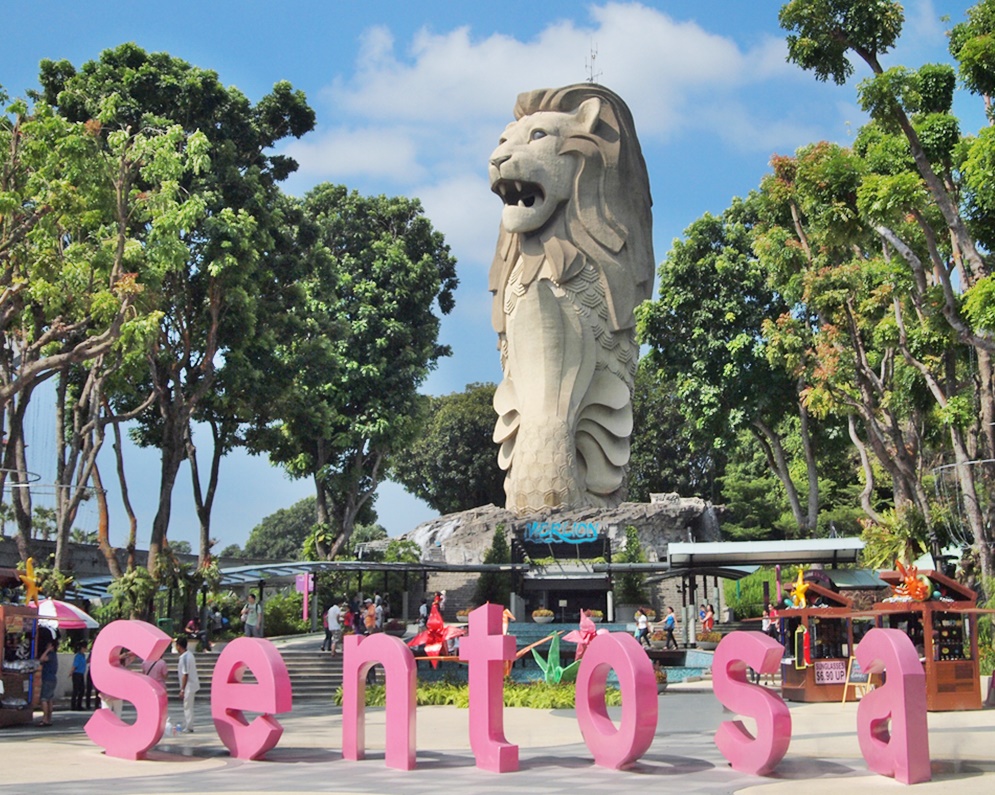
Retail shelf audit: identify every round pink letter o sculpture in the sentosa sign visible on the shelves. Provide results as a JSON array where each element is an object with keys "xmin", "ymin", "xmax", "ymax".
[{"xmin": 576, "ymin": 632, "xmax": 658, "ymax": 769}]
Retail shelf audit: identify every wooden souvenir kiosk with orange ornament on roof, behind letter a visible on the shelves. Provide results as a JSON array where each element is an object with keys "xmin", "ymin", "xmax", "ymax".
[{"xmin": 873, "ymin": 568, "xmax": 986, "ymax": 712}]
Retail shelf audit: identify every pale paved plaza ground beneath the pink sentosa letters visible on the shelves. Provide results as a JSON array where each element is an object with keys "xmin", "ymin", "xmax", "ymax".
[{"xmin": 0, "ymin": 685, "xmax": 995, "ymax": 795}]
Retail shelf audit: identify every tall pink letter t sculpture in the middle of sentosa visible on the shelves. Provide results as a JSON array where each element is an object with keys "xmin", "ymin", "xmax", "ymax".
[{"xmin": 459, "ymin": 603, "xmax": 518, "ymax": 773}]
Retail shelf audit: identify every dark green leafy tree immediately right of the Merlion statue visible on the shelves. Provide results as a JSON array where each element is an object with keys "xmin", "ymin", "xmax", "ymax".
[{"xmin": 638, "ymin": 198, "xmax": 819, "ymax": 532}]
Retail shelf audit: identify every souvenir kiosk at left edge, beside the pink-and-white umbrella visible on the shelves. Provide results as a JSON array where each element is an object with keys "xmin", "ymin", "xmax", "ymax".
[{"xmin": 0, "ymin": 569, "xmax": 41, "ymax": 726}]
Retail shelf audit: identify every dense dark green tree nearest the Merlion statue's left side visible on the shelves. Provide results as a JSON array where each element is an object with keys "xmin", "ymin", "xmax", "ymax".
[{"xmin": 254, "ymin": 184, "xmax": 457, "ymax": 558}]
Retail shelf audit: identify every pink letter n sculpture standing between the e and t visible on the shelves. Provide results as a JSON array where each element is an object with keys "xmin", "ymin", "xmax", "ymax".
[{"xmin": 342, "ymin": 635, "xmax": 417, "ymax": 770}]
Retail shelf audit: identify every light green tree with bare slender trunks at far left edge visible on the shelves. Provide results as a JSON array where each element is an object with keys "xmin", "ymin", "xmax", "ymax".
[{"xmin": 0, "ymin": 91, "xmax": 208, "ymax": 569}]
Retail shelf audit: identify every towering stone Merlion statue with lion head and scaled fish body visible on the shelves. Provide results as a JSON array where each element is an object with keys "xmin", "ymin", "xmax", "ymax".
[{"xmin": 489, "ymin": 83, "xmax": 655, "ymax": 514}]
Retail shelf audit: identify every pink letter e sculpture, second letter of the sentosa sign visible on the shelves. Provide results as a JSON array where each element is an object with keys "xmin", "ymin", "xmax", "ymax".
[{"xmin": 211, "ymin": 638, "xmax": 293, "ymax": 759}]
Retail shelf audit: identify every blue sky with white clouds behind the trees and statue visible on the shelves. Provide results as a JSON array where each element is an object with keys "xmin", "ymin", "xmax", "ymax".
[{"xmin": 0, "ymin": 0, "xmax": 984, "ymax": 549}]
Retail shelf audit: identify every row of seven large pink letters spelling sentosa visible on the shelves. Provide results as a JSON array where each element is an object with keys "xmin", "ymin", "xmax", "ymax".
[{"xmin": 86, "ymin": 604, "xmax": 930, "ymax": 784}]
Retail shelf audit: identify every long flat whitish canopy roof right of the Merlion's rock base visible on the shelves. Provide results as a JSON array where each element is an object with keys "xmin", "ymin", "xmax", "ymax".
[{"xmin": 667, "ymin": 538, "xmax": 864, "ymax": 568}]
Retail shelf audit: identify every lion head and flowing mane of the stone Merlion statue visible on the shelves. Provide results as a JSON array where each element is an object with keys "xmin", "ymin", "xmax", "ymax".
[{"xmin": 489, "ymin": 83, "xmax": 655, "ymax": 333}]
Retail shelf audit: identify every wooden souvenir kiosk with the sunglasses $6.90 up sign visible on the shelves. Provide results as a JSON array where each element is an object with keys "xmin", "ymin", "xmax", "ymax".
[{"xmin": 777, "ymin": 582, "xmax": 856, "ymax": 701}]
